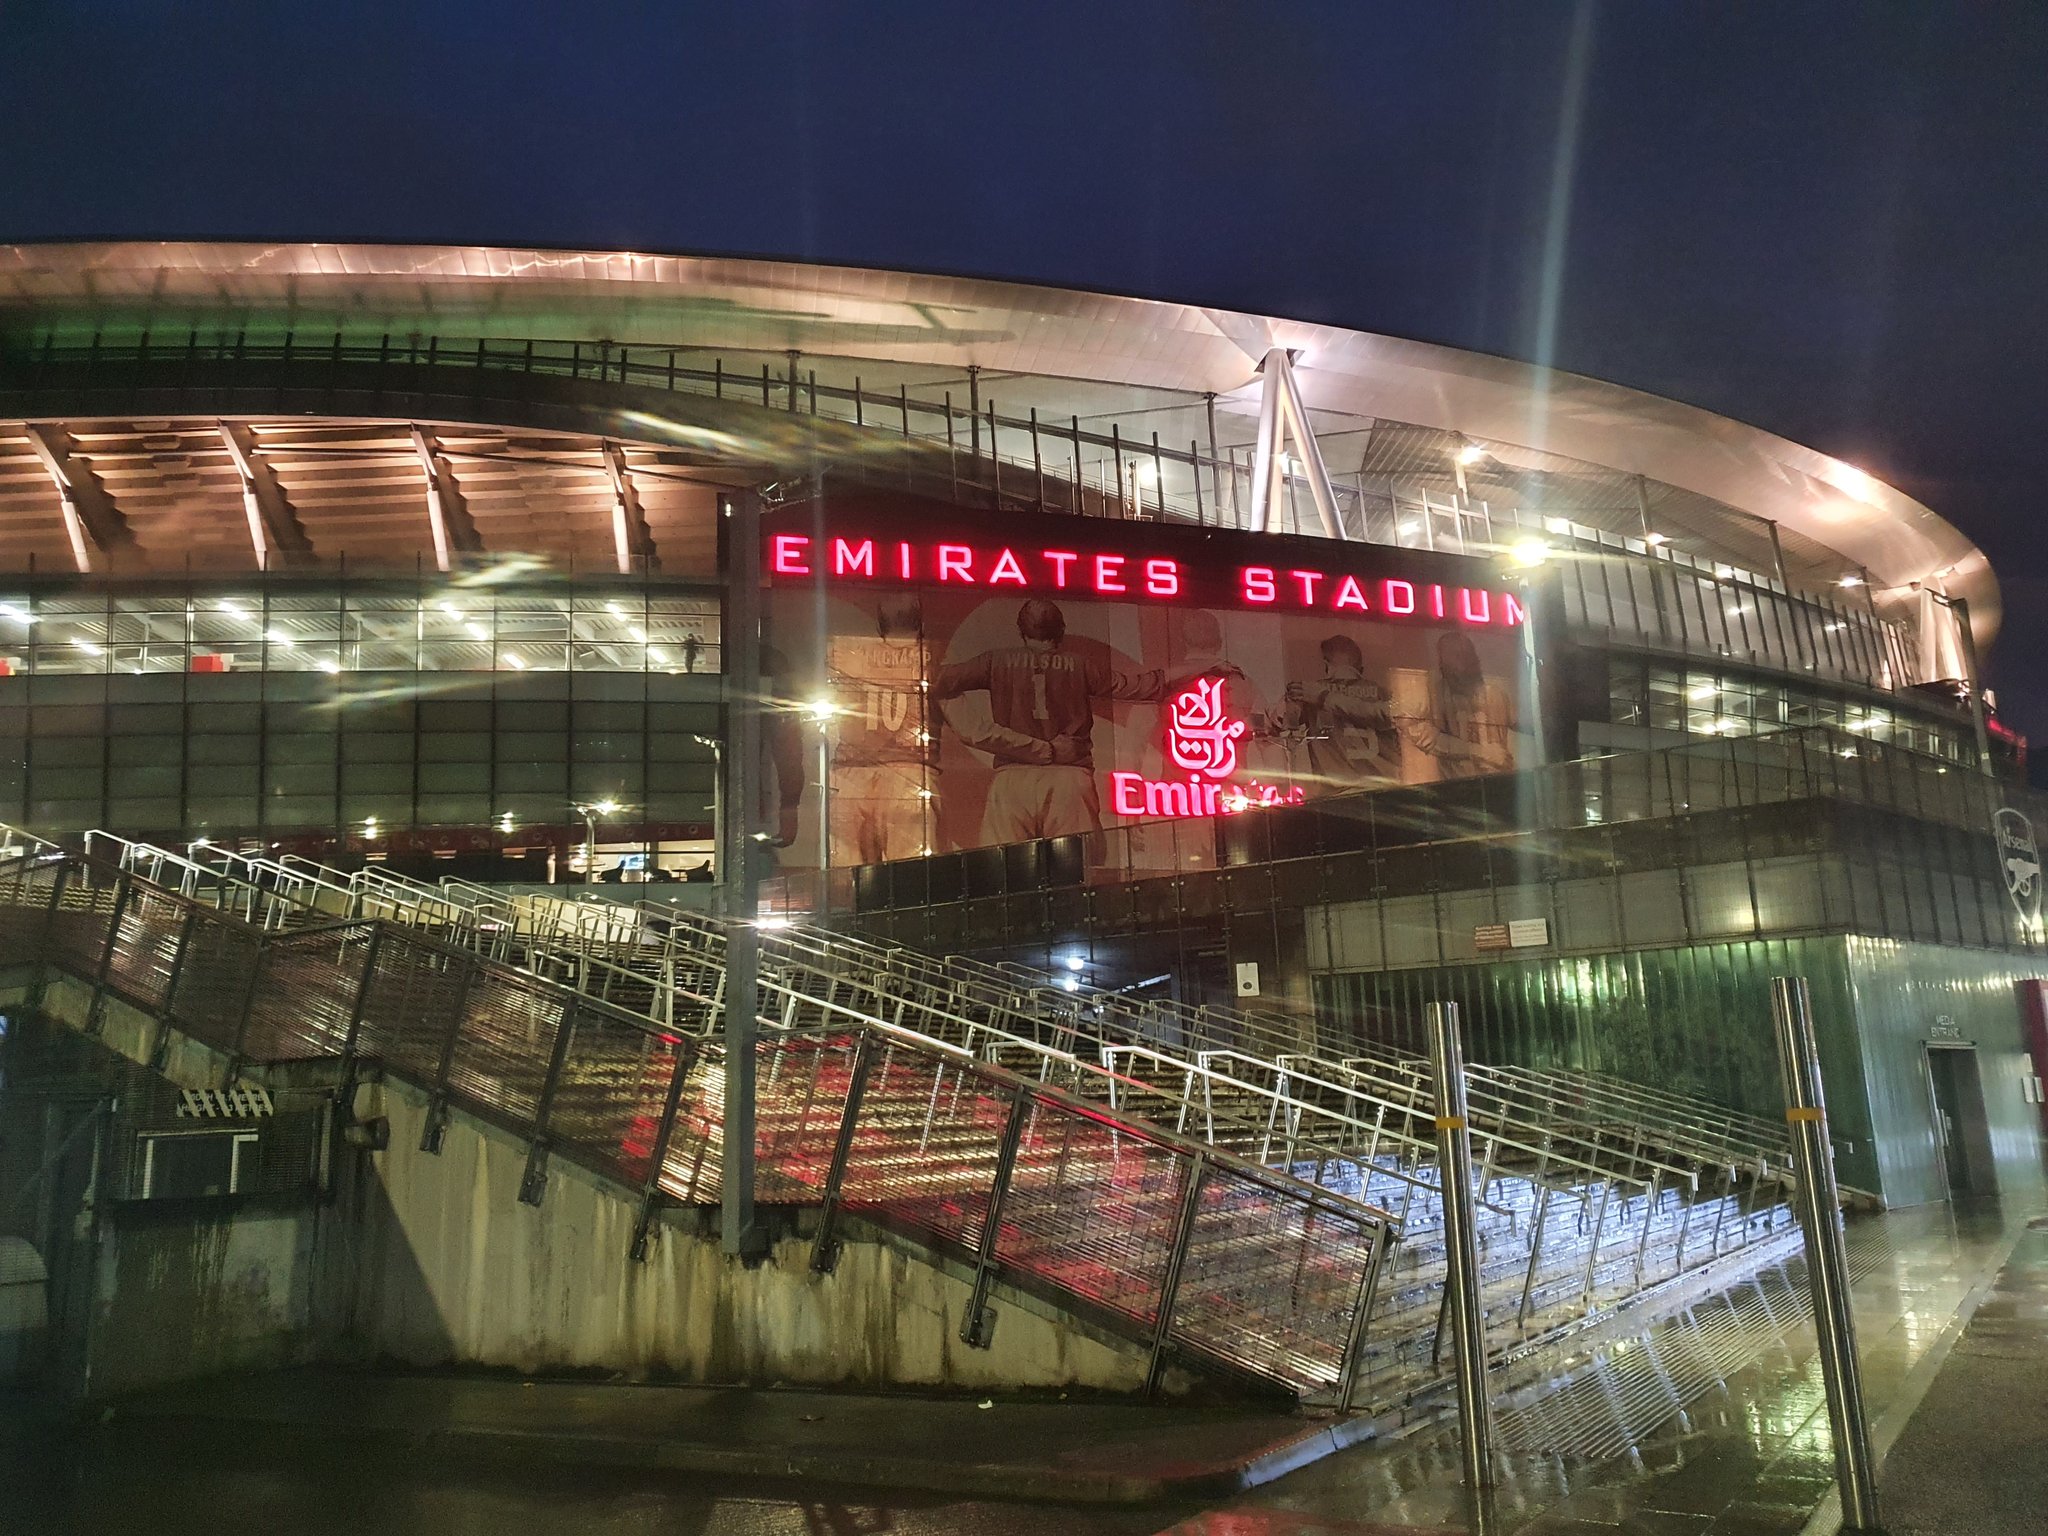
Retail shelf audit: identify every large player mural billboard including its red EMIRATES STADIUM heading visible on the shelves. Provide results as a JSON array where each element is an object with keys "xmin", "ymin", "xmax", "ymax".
[{"xmin": 768, "ymin": 501, "xmax": 1530, "ymax": 864}]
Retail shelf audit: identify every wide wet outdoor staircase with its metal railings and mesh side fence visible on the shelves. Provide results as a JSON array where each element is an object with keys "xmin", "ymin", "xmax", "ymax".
[{"xmin": 0, "ymin": 831, "xmax": 1796, "ymax": 1405}]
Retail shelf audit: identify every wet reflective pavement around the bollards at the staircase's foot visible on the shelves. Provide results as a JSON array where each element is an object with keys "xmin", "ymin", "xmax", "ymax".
[{"xmin": 1184, "ymin": 1206, "xmax": 2048, "ymax": 1536}]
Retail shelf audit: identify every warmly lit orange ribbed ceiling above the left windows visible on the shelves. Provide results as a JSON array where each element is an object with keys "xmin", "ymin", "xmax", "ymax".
[{"xmin": 0, "ymin": 416, "xmax": 729, "ymax": 578}]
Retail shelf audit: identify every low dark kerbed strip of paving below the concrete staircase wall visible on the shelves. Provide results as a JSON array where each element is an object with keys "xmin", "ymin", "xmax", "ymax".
[{"xmin": 102, "ymin": 1370, "xmax": 1348, "ymax": 1524}]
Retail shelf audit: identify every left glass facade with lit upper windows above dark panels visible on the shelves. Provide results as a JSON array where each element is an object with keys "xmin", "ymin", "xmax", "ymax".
[{"xmin": 0, "ymin": 580, "xmax": 723, "ymax": 848}]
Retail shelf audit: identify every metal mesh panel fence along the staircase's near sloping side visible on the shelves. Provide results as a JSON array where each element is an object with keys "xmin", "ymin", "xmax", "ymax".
[{"xmin": 0, "ymin": 844, "xmax": 1399, "ymax": 1397}]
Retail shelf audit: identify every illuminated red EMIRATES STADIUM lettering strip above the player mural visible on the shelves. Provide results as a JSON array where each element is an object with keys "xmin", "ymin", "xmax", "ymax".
[{"xmin": 766, "ymin": 532, "xmax": 1524, "ymax": 627}]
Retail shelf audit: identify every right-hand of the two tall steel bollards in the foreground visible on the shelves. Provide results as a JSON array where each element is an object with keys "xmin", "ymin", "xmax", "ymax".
[{"xmin": 1772, "ymin": 977, "xmax": 1878, "ymax": 1532}]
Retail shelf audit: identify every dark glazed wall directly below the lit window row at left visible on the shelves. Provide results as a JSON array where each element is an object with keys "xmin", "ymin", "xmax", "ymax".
[{"xmin": 0, "ymin": 672, "xmax": 719, "ymax": 842}]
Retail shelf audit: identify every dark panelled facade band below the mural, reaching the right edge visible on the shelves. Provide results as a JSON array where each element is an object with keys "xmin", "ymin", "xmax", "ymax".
[{"xmin": 850, "ymin": 727, "xmax": 2048, "ymax": 971}]
